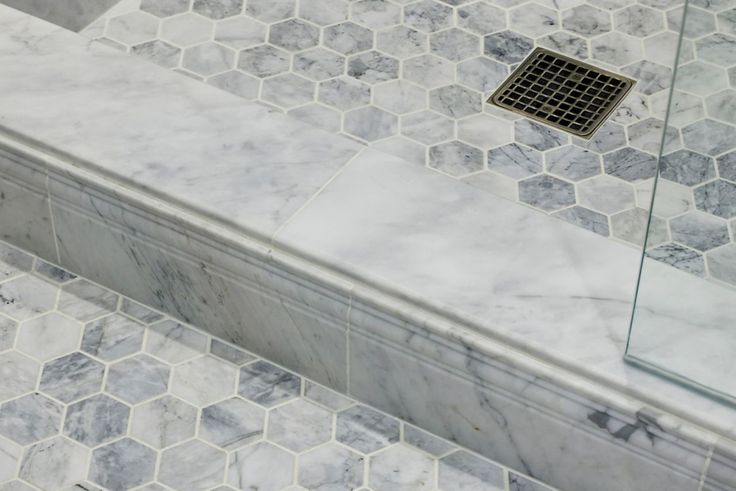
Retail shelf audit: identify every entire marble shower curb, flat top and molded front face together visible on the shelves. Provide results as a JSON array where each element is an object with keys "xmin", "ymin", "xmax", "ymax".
[{"xmin": 0, "ymin": 7, "xmax": 736, "ymax": 491}]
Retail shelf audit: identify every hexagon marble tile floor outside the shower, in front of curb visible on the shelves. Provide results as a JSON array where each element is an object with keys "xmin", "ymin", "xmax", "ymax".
[{"xmin": 0, "ymin": 242, "xmax": 552, "ymax": 491}]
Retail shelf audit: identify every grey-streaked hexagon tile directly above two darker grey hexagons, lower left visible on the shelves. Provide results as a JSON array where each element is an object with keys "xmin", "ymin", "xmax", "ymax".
[{"xmin": 82, "ymin": 314, "xmax": 144, "ymax": 361}]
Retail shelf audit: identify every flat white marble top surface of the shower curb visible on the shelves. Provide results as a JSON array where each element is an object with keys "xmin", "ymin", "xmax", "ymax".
[{"xmin": 0, "ymin": 6, "xmax": 736, "ymax": 446}]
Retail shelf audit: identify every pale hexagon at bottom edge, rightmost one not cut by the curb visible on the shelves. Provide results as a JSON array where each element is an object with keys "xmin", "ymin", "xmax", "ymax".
[{"xmin": 368, "ymin": 444, "xmax": 436, "ymax": 491}]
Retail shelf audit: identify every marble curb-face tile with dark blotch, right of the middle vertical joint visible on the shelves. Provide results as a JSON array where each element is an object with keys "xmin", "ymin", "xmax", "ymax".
[{"xmin": 350, "ymin": 300, "xmax": 707, "ymax": 491}]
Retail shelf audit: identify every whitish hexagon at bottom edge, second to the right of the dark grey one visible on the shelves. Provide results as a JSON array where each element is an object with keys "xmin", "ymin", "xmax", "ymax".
[{"xmin": 227, "ymin": 442, "xmax": 294, "ymax": 490}]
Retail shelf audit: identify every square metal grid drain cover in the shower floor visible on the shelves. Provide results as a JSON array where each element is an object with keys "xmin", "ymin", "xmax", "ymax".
[{"xmin": 488, "ymin": 48, "xmax": 636, "ymax": 138}]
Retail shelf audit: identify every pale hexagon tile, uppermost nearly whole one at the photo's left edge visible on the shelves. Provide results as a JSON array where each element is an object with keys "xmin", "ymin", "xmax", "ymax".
[{"xmin": 0, "ymin": 276, "xmax": 56, "ymax": 320}]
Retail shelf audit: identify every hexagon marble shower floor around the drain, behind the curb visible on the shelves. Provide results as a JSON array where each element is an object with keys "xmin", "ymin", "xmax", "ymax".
[{"xmin": 77, "ymin": 0, "xmax": 736, "ymax": 285}]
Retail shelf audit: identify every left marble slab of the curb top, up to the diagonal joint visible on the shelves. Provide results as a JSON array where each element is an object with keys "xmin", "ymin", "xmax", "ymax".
[{"xmin": 0, "ymin": 3, "xmax": 362, "ymax": 242}]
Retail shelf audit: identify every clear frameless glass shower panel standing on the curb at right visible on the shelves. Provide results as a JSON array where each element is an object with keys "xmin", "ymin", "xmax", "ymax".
[{"xmin": 626, "ymin": 2, "xmax": 736, "ymax": 402}]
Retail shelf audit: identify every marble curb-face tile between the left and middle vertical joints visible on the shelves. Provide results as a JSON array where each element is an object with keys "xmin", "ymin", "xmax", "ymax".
[{"xmin": 48, "ymin": 186, "xmax": 347, "ymax": 390}]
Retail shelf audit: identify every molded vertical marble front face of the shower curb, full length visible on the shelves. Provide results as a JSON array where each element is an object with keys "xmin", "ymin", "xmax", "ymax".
[{"xmin": 0, "ymin": 138, "xmax": 736, "ymax": 491}]
